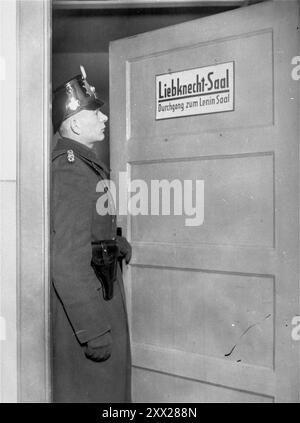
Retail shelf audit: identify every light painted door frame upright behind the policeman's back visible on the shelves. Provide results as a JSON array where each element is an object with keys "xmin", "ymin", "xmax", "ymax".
[{"xmin": 16, "ymin": 0, "xmax": 300, "ymax": 402}]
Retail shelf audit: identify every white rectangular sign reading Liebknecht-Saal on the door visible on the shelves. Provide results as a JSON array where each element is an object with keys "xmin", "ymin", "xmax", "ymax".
[{"xmin": 156, "ymin": 62, "xmax": 234, "ymax": 120}]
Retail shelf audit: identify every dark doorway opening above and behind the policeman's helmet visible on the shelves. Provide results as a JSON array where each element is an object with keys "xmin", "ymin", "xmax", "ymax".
[{"xmin": 52, "ymin": 1, "xmax": 238, "ymax": 165}]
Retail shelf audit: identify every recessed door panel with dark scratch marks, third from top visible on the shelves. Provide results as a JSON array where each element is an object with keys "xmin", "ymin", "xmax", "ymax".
[{"xmin": 132, "ymin": 266, "xmax": 274, "ymax": 368}]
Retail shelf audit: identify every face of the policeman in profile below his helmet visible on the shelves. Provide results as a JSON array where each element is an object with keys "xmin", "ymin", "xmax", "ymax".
[{"xmin": 76, "ymin": 109, "xmax": 108, "ymax": 143}]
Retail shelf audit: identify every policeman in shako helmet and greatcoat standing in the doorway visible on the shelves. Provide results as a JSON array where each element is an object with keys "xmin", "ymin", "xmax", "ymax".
[{"xmin": 51, "ymin": 67, "xmax": 131, "ymax": 403}]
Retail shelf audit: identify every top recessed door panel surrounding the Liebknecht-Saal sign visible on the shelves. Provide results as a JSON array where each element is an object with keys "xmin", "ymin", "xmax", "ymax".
[{"xmin": 128, "ymin": 29, "xmax": 273, "ymax": 139}]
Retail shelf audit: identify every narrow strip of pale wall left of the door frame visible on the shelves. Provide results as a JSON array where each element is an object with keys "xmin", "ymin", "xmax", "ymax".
[{"xmin": 0, "ymin": 0, "xmax": 17, "ymax": 402}]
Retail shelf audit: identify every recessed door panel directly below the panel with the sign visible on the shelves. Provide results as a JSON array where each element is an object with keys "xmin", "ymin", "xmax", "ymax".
[{"xmin": 131, "ymin": 154, "xmax": 274, "ymax": 247}]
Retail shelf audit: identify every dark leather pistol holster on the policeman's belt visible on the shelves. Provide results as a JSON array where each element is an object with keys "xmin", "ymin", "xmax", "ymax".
[{"xmin": 91, "ymin": 239, "xmax": 119, "ymax": 301}]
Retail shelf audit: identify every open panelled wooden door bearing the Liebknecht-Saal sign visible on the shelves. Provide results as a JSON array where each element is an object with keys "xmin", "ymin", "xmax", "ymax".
[{"xmin": 110, "ymin": 1, "xmax": 299, "ymax": 402}]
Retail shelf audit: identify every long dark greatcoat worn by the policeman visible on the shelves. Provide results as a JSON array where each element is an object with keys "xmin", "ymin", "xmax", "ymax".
[{"xmin": 51, "ymin": 138, "xmax": 131, "ymax": 403}]
